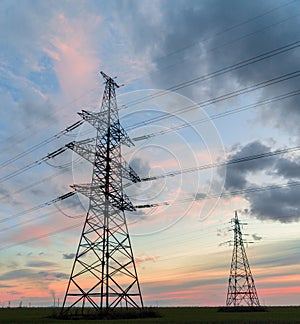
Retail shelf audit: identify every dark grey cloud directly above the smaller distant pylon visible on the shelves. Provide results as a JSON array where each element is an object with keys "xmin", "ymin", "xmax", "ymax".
[{"xmin": 218, "ymin": 141, "xmax": 300, "ymax": 221}]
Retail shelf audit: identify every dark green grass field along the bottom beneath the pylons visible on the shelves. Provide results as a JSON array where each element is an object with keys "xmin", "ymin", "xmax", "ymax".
[{"xmin": 0, "ymin": 307, "xmax": 300, "ymax": 324}]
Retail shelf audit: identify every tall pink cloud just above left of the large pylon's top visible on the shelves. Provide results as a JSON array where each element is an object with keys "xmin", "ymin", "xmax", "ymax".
[{"xmin": 43, "ymin": 13, "xmax": 102, "ymax": 121}]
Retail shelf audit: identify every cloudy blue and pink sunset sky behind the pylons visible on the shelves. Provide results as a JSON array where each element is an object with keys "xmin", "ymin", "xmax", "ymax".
[{"xmin": 0, "ymin": 0, "xmax": 300, "ymax": 307}]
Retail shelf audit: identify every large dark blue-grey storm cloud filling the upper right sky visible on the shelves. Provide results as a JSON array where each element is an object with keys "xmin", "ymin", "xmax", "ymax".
[{"xmin": 118, "ymin": 0, "xmax": 300, "ymax": 133}]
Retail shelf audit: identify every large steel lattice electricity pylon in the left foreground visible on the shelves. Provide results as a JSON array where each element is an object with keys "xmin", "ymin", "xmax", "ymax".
[{"xmin": 61, "ymin": 72, "xmax": 143, "ymax": 315}]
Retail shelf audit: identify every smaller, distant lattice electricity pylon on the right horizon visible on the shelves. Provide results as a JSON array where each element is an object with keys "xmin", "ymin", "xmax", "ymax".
[{"xmin": 226, "ymin": 212, "xmax": 260, "ymax": 307}]
